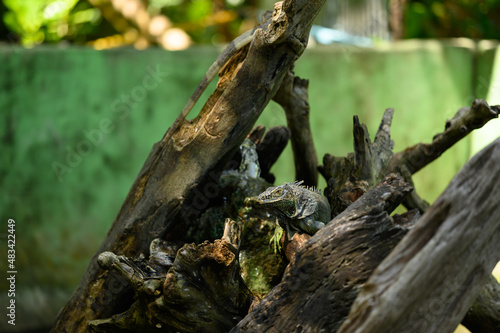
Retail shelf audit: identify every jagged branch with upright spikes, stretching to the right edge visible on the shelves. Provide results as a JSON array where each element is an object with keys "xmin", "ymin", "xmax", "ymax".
[{"xmin": 320, "ymin": 99, "xmax": 500, "ymax": 214}]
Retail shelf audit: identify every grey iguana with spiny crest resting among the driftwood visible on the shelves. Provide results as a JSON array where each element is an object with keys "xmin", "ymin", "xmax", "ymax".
[{"xmin": 246, "ymin": 182, "xmax": 331, "ymax": 241}]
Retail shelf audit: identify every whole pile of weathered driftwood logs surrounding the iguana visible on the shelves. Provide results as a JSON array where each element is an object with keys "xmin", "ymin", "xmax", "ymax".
[{"xmin": 52, "ymin": 0, "xmax": 500, "ymax": 333}]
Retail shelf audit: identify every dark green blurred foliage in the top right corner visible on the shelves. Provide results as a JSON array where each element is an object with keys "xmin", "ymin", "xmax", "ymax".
[{"xmin": 404, "ymin": 0, "xmax": 500, "ymax": 39}]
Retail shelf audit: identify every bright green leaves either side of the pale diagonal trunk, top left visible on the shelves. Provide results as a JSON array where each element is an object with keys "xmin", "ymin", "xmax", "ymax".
[{"xmin": 0, "ymin": 0, "xmax": 256, "ymax": 47}]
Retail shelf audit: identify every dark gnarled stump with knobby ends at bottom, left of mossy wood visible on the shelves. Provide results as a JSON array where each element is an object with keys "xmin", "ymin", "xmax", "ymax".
[{"xmin": 90, "ymin": 219, "xmax": 252, "ymax": 333}]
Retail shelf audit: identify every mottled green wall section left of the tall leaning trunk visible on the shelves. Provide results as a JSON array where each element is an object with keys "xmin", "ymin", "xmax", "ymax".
[{"xmin": 0, "ymin": 48, "xmax": 216, "ymax": 287}]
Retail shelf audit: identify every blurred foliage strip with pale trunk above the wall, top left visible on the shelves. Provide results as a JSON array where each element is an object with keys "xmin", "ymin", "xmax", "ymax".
[{"xmin": 0, "ymin": 0, "xmax": 257, "ymax": 49}]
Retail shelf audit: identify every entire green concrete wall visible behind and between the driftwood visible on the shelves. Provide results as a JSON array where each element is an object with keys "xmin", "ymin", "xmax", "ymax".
[{"xmin": 0, "ymin": 40, "xmax": 500, "ymax": 330}]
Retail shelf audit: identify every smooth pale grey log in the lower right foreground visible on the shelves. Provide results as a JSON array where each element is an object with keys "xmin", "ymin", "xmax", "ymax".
[{"xmin": 339, "ymin": 139, "xmax": 500, "ymax": 333}]
